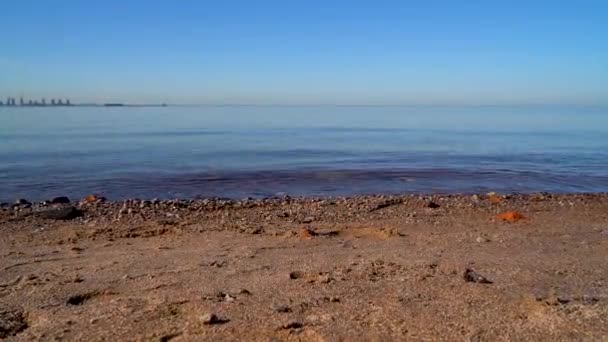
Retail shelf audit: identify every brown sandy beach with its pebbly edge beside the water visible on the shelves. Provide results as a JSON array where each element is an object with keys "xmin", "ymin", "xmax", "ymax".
[{"xmin": 0, "ymin": 194, "xmax": 608, "ymax": 341}]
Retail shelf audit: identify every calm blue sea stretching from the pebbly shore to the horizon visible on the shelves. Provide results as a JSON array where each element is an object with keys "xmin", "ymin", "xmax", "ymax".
[{"xmin": 0, "ymin": 106, "xmax": 608, "ymax": 201}]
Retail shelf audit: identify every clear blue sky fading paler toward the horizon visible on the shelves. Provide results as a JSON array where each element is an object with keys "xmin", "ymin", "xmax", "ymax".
[{"xmin": 0, "ymin": 0, "xmax": 608, "ymax": 105}]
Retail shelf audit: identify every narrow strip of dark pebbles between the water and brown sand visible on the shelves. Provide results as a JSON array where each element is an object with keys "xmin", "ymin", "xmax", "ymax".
[{"xmin": 0, "ymin": 192, "xmax": 608, "ymax": 217}]
